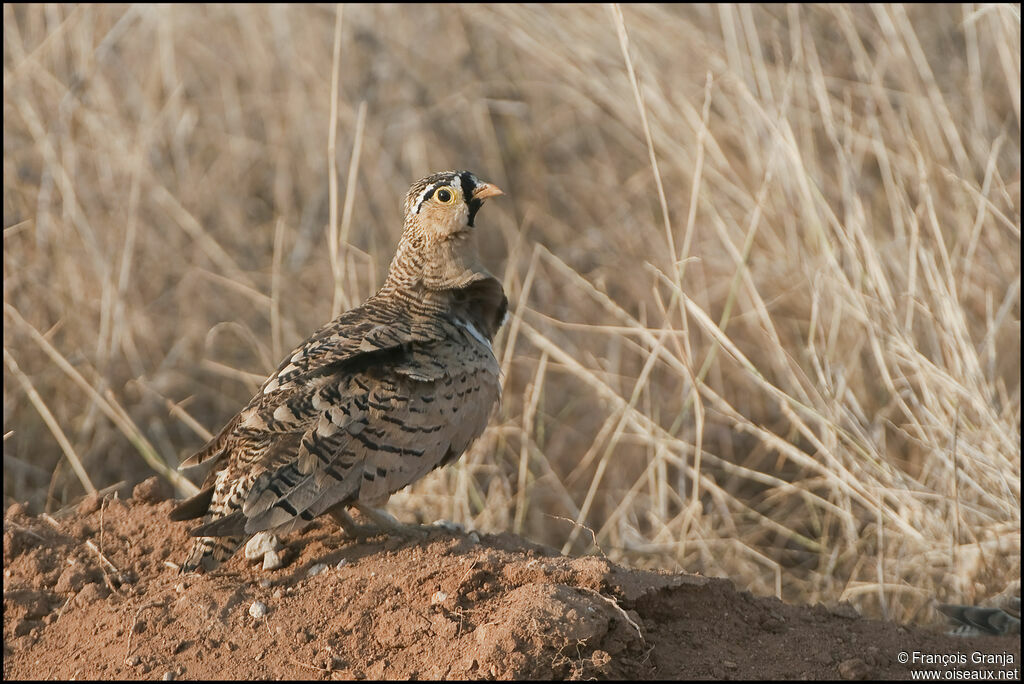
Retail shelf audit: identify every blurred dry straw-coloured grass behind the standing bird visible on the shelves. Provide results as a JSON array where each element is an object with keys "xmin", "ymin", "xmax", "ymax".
[{"xmin": 3, "ymin": 4, "xmax": 1021, "ymax": 621}]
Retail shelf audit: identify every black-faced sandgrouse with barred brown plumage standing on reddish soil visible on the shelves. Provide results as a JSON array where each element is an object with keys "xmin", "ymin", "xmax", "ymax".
[{"xmin": 171, "ymin": 171, "xmax": 508, "ymax": 571}]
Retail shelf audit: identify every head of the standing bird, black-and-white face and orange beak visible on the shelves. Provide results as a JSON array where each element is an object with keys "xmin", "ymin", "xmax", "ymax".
[{"xmin": 406, "ymin": 171, "xmax": 503, "ymax": 243}]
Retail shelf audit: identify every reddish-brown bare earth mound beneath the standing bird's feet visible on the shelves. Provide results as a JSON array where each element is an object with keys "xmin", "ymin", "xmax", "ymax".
[{"xmin": 3, "ymin": 479, "xmax": 1020, "ymax": 679}]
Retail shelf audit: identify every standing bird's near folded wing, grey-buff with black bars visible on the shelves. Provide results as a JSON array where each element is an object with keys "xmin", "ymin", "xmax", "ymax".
[{"xmin": 193, "ymin": 338, "xmax": 499, "ymax": 537}]
